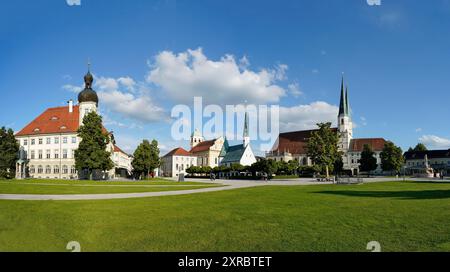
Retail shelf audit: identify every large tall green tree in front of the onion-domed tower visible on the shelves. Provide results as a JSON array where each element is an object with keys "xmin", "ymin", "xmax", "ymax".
[{"xmin": 75, "ymin": 112, "xmax": 114, "ymax": 178}]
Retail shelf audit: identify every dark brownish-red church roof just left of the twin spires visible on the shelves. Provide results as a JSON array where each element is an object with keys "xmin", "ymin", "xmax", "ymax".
[{"xmin": 272, "ymin": 128, "xmax": 337, "ymax": 154}]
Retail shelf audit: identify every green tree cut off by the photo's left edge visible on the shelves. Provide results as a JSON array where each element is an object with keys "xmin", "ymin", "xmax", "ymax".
[{"xmin": 0, "ymin": 127, "xmax": 19, "ymax": 179}]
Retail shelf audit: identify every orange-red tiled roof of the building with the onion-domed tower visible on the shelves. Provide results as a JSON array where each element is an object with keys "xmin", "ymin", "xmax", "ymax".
[{"xmin": 16, "ymin": 106, "xmax": 80, "ymax": 136}]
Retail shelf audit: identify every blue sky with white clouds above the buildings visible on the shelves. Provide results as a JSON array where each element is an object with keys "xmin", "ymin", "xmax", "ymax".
[{"xmin": 0, "ymin": 0, "xmax": 450, "ymax": 152}]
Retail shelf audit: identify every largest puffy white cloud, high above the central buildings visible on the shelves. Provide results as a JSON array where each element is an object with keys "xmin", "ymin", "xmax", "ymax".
[{"xmin": 147, "ymin": 48, "xmax": 288, "ymax": 104}]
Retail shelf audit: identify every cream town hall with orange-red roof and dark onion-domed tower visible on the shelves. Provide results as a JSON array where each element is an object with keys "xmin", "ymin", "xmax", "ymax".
[{"xmin": 15, "ymin": 67, "xmax": 132, "ymax": 179}]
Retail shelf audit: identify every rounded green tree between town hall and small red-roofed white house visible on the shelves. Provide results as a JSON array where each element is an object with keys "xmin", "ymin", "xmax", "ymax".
[{"xmin": 131, "ymin": 140, "xmax": 162, "ymax": 179}]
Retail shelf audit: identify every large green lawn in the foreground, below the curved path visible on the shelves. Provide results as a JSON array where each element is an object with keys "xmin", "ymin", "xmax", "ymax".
[{"xmin": 0, "ymin": 182, "xmax": 450, "ymax": 251}]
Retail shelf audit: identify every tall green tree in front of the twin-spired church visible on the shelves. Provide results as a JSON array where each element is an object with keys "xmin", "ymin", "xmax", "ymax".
[{"xmin": 307, "ymin": 123, "xmax": 342, "ymax": 178}]
